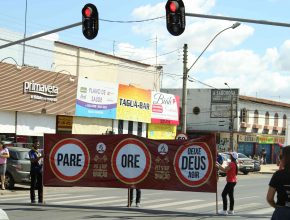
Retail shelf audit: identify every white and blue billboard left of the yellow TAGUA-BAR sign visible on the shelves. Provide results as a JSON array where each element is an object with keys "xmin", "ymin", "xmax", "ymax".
[{"xmin": 76, "ymin": 78, "xmax": 118, "ymax": 119}]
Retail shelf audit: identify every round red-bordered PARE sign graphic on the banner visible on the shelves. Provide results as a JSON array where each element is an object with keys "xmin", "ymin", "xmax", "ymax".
[{"xmin": 49, "ymin": 139, "xmax": 90, "ymax": 182}]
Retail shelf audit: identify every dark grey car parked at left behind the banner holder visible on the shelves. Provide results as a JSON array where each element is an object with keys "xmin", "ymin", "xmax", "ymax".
[{"xmin": 5, "ymin": 147, "xmax": 30, "ymax": 189}]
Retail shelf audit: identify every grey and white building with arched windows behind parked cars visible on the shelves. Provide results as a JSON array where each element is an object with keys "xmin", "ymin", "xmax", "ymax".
[{"xmin": 161, "ymin": 89, "xmax": 290, "ymax": 163}]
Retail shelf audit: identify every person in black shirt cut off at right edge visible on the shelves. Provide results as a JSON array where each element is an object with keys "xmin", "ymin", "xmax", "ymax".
[{"xmin": 267, "ymin": 145, "xmax": 290, "ymax": 220}]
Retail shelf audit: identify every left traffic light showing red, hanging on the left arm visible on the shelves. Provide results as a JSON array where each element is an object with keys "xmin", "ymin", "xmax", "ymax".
[{"xmin": 82, "ymin": 4, "xmax": 99, "ymax": 40}]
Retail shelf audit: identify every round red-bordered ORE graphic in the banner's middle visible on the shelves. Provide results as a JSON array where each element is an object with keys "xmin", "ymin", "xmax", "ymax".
[{"xmin": 111, "ymin": 138, "xmax": 151, "ymax": 184}]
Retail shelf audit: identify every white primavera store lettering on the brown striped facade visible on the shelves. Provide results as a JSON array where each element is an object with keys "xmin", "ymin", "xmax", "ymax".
[{"xmin": 23, "ymin": 81, "xmax": 58, "ymax": 102}]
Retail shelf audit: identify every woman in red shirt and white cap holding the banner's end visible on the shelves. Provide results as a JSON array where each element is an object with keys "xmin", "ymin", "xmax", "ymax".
[{"xmin": 216, "ymin": 152, "xmax": 238, "ymax": 215}]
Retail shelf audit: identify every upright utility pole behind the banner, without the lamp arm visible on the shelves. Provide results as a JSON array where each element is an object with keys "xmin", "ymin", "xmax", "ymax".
[{"xmin": 181, "ymin": 44, "xmax": 188, "ymax": 133}]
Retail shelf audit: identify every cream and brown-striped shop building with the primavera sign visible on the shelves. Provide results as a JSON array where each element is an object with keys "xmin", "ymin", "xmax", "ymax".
[{"xmin": 0, "ymin": 28, "xmax": 162, "ymax": 143}]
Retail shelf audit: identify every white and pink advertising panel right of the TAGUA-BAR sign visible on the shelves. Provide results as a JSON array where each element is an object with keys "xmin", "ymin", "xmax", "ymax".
[{"xmin": 151, "ymin": 91, "xmax": 180, "ymax": 125}]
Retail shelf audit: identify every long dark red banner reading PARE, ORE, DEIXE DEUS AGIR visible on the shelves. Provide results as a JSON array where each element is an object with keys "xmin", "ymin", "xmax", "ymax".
[{"xmin": 43, "ymin": 134, "xmax": 217, "ymax": 192}]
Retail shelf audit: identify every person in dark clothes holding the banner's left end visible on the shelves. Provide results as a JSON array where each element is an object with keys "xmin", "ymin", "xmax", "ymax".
[{"xmin": 29, "ymin": 141, "xmax": 43, "ymax": 203}]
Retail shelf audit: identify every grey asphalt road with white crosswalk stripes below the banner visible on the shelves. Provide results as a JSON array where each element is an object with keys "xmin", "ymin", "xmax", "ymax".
[{"xmin": 0, "ymin": 174, "xmax": 273, "ymax": 220}]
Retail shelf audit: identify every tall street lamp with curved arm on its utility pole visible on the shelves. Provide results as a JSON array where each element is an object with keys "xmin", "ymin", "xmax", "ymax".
[{"xmin": 181, "ymin": 22, "xmax": 241, "ymax": 133}]
